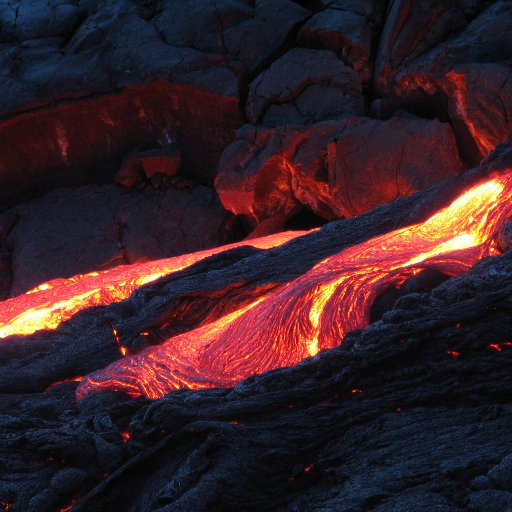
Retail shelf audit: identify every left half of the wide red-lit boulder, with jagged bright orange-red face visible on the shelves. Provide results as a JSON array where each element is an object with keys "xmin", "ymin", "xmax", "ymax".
[{"xmin": 215, "ymin": 121, "xmax": 346, "ymax": 223}]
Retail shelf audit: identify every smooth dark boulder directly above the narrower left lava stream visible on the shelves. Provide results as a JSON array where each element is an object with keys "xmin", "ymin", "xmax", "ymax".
[{"xmin": 0, "ymin": 185, "xmax": 231, "ymax": 296}]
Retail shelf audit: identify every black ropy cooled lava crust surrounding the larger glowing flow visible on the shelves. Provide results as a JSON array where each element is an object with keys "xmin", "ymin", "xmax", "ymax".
[{"xmin": 0, "ymin": 158, "xmax": 512, "ymax": 512}]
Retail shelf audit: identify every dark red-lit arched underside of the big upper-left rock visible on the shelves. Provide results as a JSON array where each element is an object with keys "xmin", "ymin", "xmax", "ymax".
[{"xmin": 0, "ymin": 82, "xmax": 240, "ymax": 208}]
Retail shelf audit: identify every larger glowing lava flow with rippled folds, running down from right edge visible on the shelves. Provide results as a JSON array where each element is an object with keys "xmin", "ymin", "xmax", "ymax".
[{"xmin": 77, "ymin": 173, "xmax": 512, "ymax": 399}]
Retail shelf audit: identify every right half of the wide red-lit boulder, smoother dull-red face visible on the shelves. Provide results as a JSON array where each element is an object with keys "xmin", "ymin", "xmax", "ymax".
[{"xmin": 329, "ymin": 118, "xmax": 463, "ymax": 217}]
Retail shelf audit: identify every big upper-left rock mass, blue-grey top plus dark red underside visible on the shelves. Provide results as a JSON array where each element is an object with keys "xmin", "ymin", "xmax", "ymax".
[{"xmin": 0, "ymin": 2, "xmax": 245, "ymax": 209}]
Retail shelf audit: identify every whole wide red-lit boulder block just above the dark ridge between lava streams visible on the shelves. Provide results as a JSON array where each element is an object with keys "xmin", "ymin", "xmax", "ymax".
[{"xmin": 215, "ymin": 118, "xmax": 462, "ymax": 222}]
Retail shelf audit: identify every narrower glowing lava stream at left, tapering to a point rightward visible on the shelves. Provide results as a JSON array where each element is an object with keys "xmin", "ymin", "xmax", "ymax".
[{"xmin": 0, "ymin": 231, "xmax": 305, "ymax": 338}]
